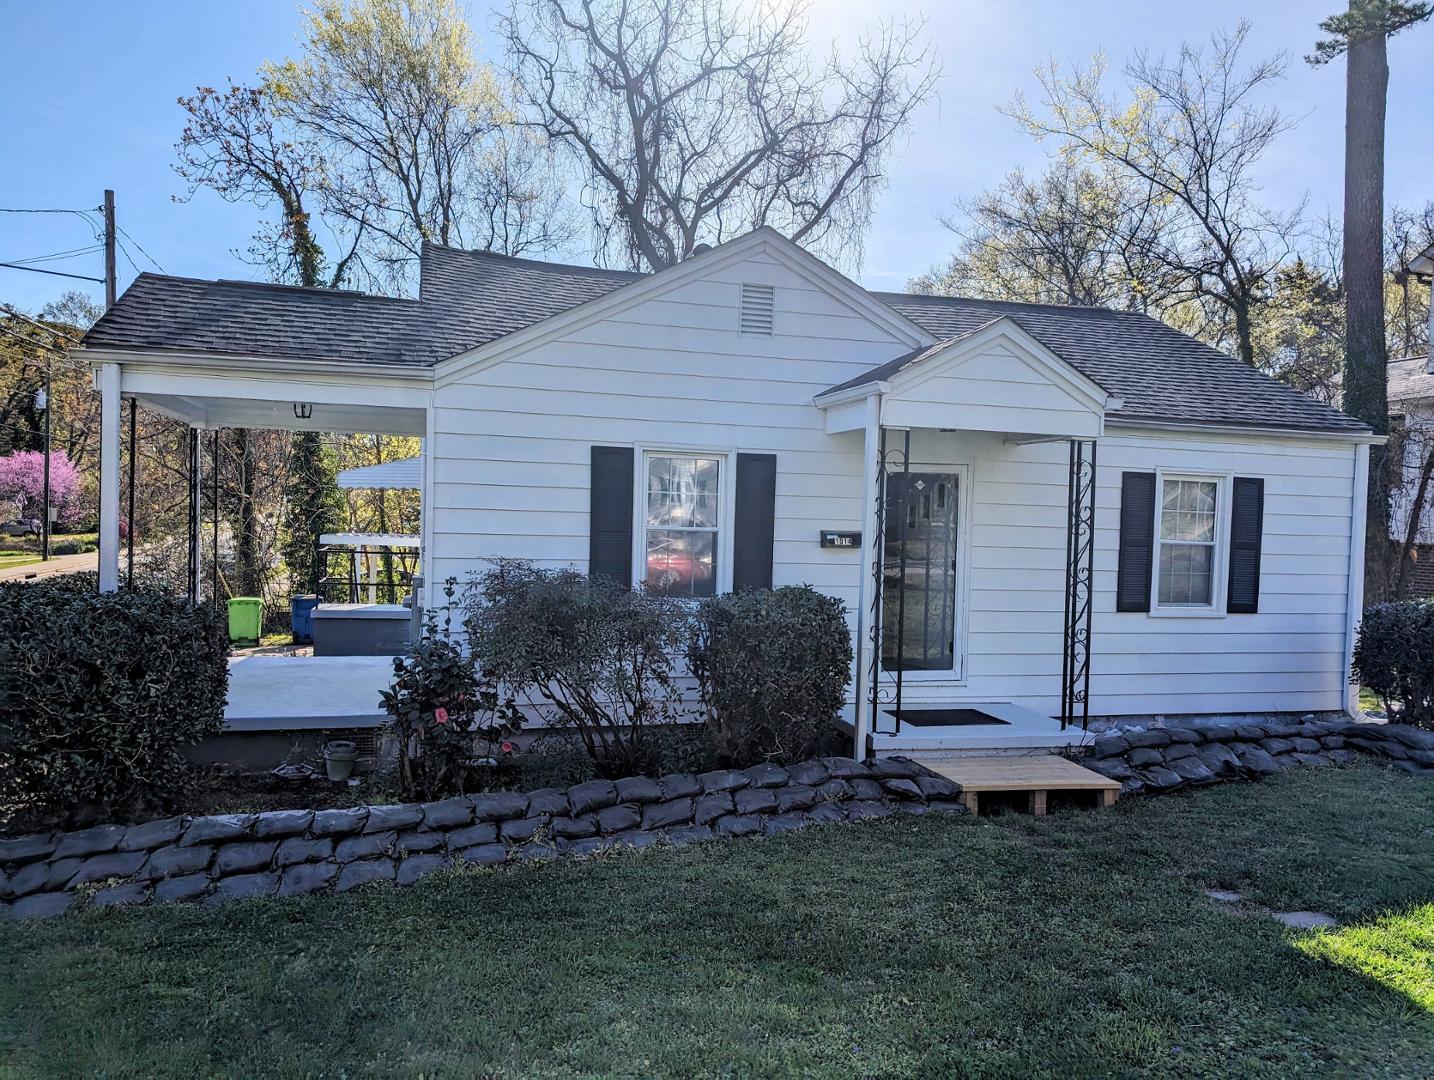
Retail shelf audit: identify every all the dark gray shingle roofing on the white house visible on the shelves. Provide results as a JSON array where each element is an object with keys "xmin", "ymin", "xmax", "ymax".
[{"xmin": 85, "ymin": 245, "xmax": 1368, "ymax": 432}]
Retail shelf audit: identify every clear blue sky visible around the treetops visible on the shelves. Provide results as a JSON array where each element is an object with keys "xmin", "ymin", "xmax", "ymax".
[{"xmin": 0, "ymin": 0, "xmax": 1434, "ymax": 308}]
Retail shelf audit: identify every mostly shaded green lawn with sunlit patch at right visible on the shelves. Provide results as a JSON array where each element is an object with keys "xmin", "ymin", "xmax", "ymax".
[{"xmin": 0, "ymin": 766, "xmax": 1434, "ymax": 1077}]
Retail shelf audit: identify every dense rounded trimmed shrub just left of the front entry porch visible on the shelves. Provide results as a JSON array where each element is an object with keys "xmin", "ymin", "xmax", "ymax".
[{"xmin": 687, "ymin": 585, "xmax": 852, "ymax": 764}]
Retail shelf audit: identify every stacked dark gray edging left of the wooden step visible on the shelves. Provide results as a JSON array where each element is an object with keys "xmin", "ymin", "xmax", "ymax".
[{"xmin": 0, "ymin": 757, "xmax": 964, "ymax": 918}]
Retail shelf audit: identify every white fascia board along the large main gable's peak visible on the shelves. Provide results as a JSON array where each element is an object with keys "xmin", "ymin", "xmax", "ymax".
[{"xmin": 433, "ymin": 227, "xmax": 934, "ymax": 386}]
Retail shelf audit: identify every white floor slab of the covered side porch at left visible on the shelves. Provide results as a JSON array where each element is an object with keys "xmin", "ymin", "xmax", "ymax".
[{"xmin": 224, "ymin": 655, "xmax": 393, "ymax": 731}]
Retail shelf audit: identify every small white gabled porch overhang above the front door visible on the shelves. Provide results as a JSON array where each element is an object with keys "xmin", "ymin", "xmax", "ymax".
[{"xmin": 813, "ymin": 317, "xmax": 1121, "ymax": 439}]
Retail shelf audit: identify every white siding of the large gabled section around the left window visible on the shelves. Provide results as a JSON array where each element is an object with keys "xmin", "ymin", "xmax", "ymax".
[{"xmin": 432, "ymin": 246, "xmax": 911, "ymax": 607}]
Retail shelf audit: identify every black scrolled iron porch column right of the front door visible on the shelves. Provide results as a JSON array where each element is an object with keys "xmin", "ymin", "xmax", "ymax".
[{"xmin": 1061, "ymin": 439, "xmax": 1096, "ymax": 731}]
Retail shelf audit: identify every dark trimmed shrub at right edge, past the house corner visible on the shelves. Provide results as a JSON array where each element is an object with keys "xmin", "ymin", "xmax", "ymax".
[{"xmin": 1354, "ymin": 600, "xmax": 1434, "ymax": 729}]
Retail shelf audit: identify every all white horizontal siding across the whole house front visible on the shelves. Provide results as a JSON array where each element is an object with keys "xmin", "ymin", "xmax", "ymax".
[{"xmin": 430, "ymin": 249, "xmax": 1355, "ymax": 716}]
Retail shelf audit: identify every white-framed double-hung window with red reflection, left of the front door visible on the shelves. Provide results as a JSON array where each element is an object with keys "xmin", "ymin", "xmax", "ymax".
[{"xmin": 642, "ymin": 453, "xmax": 723, "ymax": 597}]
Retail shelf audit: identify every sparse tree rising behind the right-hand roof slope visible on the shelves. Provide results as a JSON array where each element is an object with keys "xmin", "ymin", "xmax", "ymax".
[{"xmin": 1008, "ymin": 23, "xmax": 1304, "ymax": 363}]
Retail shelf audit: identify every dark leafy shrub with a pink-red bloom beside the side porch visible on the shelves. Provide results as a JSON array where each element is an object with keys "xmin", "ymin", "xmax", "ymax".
[{"xmin": 380, "ymin": 581, "xmax": 522, "ymax": 799}]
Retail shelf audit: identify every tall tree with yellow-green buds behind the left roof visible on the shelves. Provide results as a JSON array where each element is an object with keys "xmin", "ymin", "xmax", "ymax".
[{"xmin": 264, "ymin": 0, "xmax": 569, "ymax": 287}]
